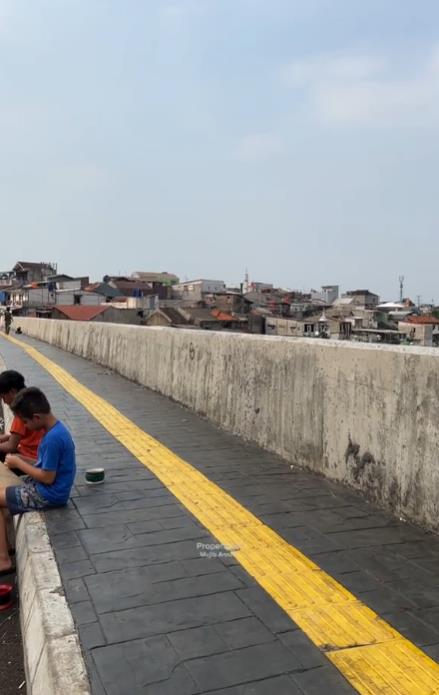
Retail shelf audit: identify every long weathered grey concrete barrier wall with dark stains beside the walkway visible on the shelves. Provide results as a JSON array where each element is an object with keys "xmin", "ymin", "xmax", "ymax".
[{"xmin": 15, "ymin": 318, "xmax": 439, "ymax": 530}]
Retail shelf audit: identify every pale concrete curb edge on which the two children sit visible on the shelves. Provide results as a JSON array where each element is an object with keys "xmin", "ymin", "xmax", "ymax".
[{"xmin": 0, "ymin": 358, "xmax": 91, "ymax": 695}]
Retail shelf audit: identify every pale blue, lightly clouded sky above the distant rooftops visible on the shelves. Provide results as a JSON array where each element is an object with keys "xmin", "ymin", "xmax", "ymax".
[{"xmin": 0, "ymin": 0, "xmax": 439, "ymax": 302}]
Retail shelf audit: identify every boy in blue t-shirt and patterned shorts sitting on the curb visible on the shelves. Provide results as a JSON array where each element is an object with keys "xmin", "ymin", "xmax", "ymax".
[{"xmin": 0, "ymin": 388, "xmax": 76, "ymax": 576}]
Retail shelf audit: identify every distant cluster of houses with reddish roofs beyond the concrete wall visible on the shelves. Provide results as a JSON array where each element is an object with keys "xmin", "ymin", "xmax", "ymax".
[{"xmin": 0, "ymin": 261, "xmax": 439, "ymax": 347}]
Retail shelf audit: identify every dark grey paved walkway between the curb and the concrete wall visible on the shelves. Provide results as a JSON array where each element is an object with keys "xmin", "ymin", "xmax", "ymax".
[{"xmin": 0, "ymin": 338, "xmax": 439, "ymax": 695}]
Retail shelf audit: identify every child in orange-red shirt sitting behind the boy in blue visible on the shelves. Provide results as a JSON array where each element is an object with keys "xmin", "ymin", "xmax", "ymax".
[{"xmin": 0, "ymin": 369, "xmax": 44, "ymax": 468}]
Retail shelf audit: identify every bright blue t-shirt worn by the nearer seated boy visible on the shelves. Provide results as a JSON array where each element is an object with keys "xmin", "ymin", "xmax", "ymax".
[{"xmin": 35, "ymin": 420, "xmax": 76, "ymax": 505}]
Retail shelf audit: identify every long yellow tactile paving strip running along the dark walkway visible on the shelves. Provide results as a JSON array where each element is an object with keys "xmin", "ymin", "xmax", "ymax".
[{"xmin": 3, "ymin": 337, "xmax": 439, "ymax": 695}]
